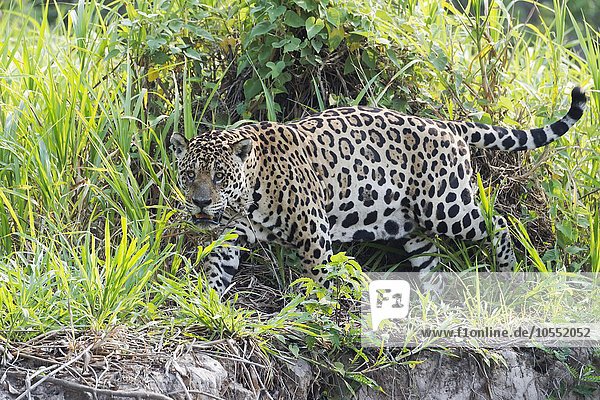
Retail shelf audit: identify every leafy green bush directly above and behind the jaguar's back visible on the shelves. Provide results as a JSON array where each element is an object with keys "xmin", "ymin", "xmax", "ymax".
[{"xmin": 109, "ymin": 0, "xmax": 424, "ymax": 124}]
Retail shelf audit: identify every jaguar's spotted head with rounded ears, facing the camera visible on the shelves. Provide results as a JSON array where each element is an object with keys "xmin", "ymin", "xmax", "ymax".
[{"xmin": 170, "ymin": 131, "xmax": 252, "ymax": 228}]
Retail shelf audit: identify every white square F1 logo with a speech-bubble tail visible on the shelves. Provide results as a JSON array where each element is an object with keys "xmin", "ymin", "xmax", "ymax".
[{"xmin": 369, "ymin": 280, "xmax": 410, "ymax": 331}]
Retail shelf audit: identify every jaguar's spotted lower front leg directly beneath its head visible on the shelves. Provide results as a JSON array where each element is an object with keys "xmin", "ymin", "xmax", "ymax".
[{"xmin": 204, "ymin": 245, "xmax": 240, "ymax": 295}]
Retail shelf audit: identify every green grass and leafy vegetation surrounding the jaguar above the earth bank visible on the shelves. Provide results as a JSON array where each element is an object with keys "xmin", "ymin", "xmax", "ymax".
[{"xmin": 0, "ymin": 0, "xmax": 600, "ymax": 391}]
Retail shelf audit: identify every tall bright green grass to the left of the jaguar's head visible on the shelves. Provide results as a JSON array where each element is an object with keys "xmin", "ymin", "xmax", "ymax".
[{"xmin": 0, "ymin": 2, "xmax": 175, "ymax": 340}]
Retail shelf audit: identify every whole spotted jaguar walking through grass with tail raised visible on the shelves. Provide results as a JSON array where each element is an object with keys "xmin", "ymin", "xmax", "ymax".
[{"xmin": 170, "ymin": 87, "xmax": 586, "ymax": 293}]
